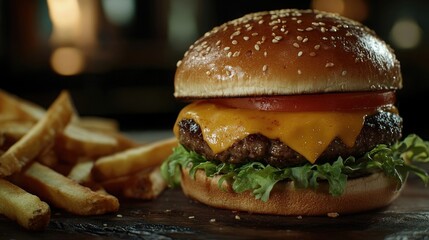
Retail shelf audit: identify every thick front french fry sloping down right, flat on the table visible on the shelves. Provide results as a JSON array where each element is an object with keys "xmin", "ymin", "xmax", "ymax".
[{"xmin": 12, "ymin": 162, "xmax": 119, "ymax": 215}]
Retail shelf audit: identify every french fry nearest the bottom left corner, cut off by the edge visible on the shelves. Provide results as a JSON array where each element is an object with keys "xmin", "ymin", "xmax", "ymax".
[{"xmin": 0, "ymin": 179, "xmax": 51, "ymax": 230}]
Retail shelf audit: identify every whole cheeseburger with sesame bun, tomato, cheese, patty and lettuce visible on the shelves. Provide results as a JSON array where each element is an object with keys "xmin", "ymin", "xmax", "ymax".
[{"xmin": 162, "ymin": 9, "xmax": 429, "ymax": 215}]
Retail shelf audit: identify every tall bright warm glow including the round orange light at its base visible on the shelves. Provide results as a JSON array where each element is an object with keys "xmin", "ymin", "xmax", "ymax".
[{"xmin": 47, "ymin": 0, "xmax": 99, "ymax": 75}]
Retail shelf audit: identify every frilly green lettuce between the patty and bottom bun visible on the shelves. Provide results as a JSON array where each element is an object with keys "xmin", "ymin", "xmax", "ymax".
[{"xmin": 161, "ymin": 134, "xmax": 429, "ymax": 201}]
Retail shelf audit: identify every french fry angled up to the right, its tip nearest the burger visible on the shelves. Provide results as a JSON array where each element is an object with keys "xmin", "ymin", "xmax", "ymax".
[{"xmin": 92, "ymin": 138, "xmax": 177, "ymax": 182}]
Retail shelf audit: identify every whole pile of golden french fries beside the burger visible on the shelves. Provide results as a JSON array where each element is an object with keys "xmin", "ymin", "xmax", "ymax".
[{"xmin": 0, "ymin": 89, "xmax": 177, "ymax": 230}]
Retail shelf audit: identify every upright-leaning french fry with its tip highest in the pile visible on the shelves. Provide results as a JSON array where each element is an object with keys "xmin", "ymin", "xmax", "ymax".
[{"xmin": 0, "ymin": 91, "xmax": 74, "ymax": 177}]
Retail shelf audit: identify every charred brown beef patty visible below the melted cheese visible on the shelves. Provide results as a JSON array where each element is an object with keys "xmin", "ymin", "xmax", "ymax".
[{"xmin": 178, "ymin": 111, "xmax": 402, "ymax": 167}]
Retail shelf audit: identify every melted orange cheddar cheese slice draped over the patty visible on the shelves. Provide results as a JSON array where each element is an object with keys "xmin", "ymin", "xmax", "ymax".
[{"xmin": 174, "ymin": 101, "xmax": 374, "ymax": 163}]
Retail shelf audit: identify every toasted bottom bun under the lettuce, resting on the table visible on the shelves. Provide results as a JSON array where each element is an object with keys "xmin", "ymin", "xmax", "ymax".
[{"xmin": 181, "ymin": 169, "xmax": 402, "ymax": 216}]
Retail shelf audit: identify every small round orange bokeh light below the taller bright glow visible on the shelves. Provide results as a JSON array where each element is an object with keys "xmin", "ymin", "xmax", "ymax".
[{"xmin": 51, "ymin": 47, "xmax": 85, "ymax": 76}]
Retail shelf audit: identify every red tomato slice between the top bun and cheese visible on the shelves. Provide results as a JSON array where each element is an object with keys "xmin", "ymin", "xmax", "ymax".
[{"xmin": 209, "ymin": 91, "xmax": 396, "ymax": 112}]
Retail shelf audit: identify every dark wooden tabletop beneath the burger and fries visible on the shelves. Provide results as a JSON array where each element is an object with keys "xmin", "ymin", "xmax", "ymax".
[{"xmin": 0, "ymin": 132, "xmax": 429, "ymax": 240}]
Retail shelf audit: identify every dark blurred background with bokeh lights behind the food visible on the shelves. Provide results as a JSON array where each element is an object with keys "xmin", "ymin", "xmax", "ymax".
[{"xmin": 0, "ymin": 0, "xmax": 429, "ymax": 139}]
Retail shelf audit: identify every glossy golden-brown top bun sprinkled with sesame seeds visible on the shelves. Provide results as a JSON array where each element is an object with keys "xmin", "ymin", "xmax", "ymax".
[{"xmin": 174, "ymin": 9, "xmax": 402, "ymax": 99}]
